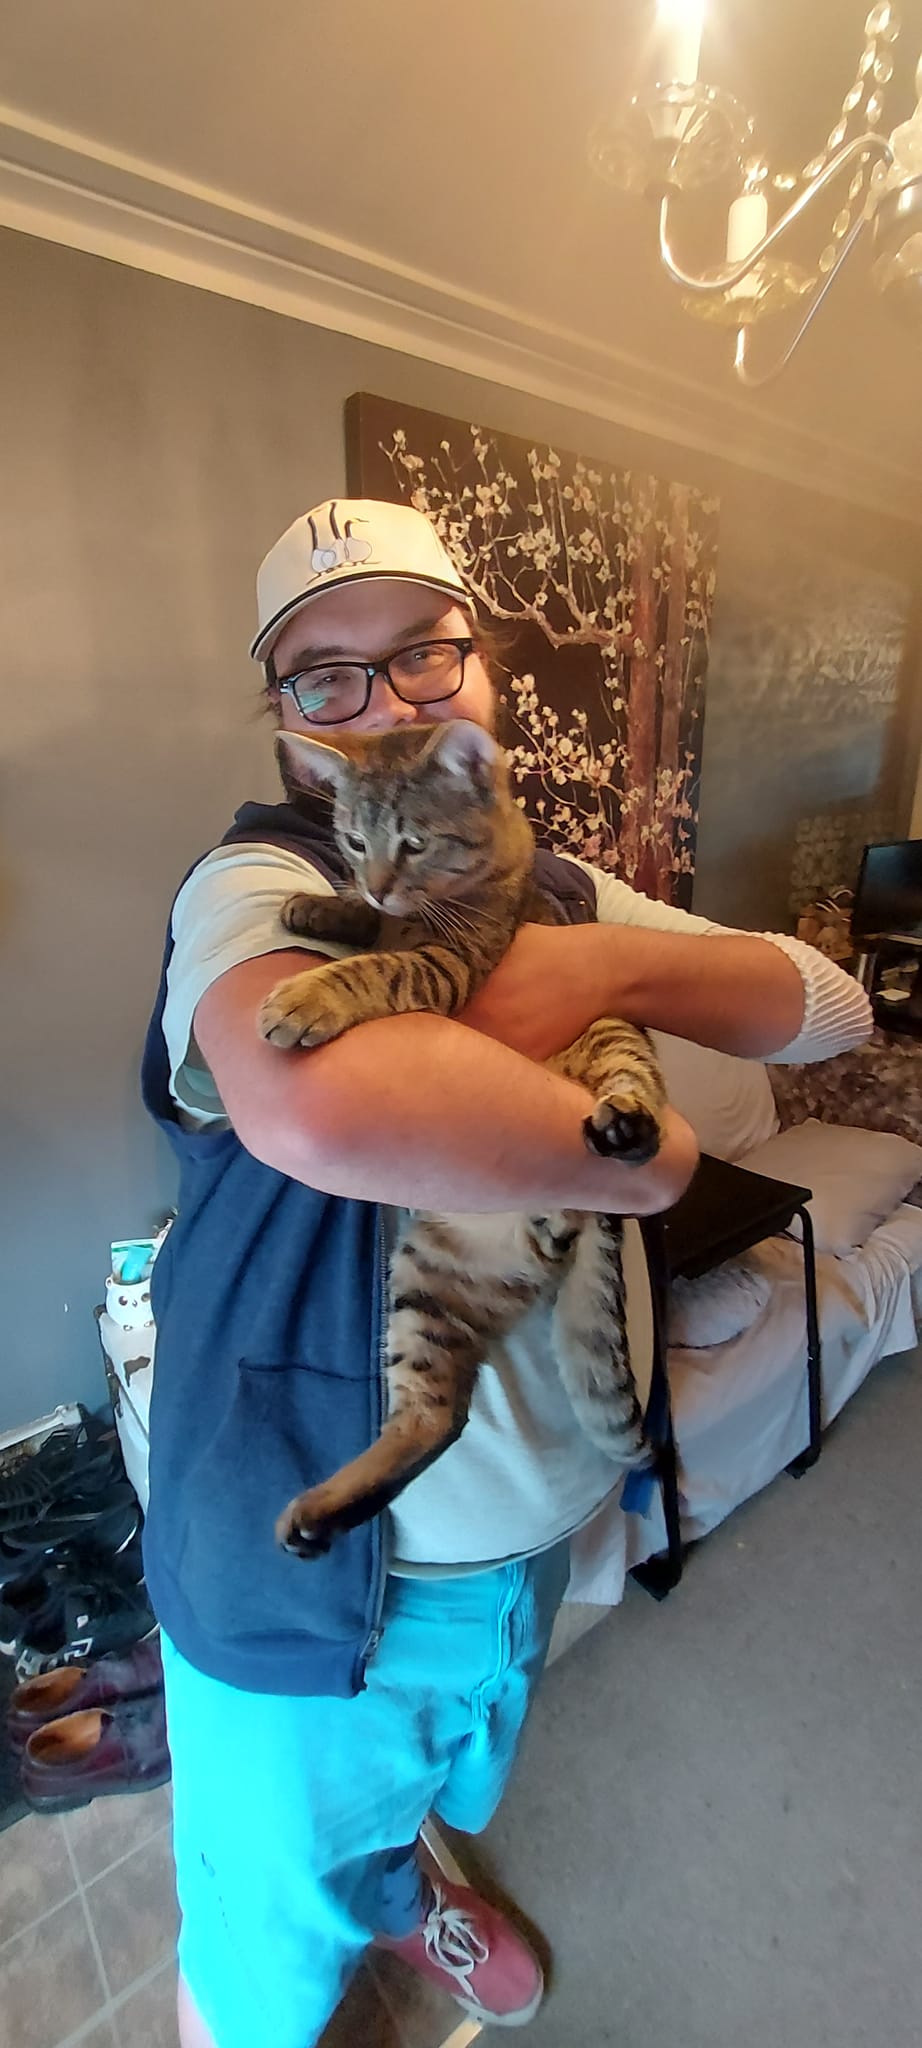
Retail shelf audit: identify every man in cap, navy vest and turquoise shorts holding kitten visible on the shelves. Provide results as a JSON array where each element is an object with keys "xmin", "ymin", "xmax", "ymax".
[{"xmin": 143, "ymin": 502, "xmax": 869, "ymax": 2048}]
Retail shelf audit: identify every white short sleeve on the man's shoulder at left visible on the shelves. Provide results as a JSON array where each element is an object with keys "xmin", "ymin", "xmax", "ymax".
[{"xmin": 164, "ymin": 842, "xmax": 352, "ymax": 1128}]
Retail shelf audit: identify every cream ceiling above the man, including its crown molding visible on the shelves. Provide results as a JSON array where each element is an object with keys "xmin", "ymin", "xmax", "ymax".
[{"xmin": 0, "ymin": 0, "xmax": 922, "ymax": 518}]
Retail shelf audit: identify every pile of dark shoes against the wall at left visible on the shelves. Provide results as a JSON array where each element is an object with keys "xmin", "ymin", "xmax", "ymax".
[{"xmin": 0, "ymin": 1409, "xmax": 170, "ymax": 1812}]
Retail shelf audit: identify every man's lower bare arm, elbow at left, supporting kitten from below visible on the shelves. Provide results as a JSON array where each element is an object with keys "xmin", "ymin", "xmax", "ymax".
[{"xmin": 195, "ymin": 950, "xmax": 697, "ymax": 1214}]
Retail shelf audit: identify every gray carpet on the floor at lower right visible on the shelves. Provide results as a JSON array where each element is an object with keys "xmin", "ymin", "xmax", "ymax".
[{"xmin": 465, "ymin": 1352, "xmax": 922, "ymax": 2048}]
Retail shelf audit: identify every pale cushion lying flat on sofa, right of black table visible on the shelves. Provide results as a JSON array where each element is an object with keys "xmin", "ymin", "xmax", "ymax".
[{"xmin": 738, "ymin": 1116, "xmax": 922, "ymax": 1257}]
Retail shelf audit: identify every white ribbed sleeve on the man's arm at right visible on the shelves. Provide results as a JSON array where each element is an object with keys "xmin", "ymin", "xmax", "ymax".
[{"xmin": 568, "ymin": 854, "xmax": 873, "ymax": 1067}]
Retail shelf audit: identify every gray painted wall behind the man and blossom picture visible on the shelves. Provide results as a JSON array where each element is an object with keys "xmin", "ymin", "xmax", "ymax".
[{"xmin": 0, "ymin": 233, "xmax": 916, "ymax": 1427}]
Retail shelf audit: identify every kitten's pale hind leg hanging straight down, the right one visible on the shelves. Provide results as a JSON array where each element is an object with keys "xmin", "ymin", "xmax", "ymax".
[{"xmin": 551, "ymin": 1214, "xmax": 647, "ymax": 1470}]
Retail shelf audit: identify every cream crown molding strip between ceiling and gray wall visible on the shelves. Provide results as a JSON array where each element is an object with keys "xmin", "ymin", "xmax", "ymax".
[{"xmin": 0, "ymin": 104, "xmax": 922, "ymax": 522}]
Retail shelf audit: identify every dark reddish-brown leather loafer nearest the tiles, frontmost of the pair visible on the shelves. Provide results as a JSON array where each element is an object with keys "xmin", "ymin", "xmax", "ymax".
[{"xmin": 23, "ymin": 1692, "xmax": 170, "ymax": 1812}]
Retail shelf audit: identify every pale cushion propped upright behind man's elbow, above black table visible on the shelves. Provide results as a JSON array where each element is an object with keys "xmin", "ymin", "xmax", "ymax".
[{"xmin": 652, "ymin": 1030, "xmax": 779, "ymax": 1161}]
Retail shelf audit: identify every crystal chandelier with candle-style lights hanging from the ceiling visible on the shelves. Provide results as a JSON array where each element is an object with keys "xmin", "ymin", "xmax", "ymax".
[{"xmin": 590, "ymin": 0, "xmax": 922, "ymax": 385}]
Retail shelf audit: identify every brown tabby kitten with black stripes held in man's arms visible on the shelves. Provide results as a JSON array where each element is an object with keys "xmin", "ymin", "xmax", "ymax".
[{"xmin": 258, "ymin": 719, "xmax": 664, "ymax": 1556}]
